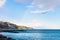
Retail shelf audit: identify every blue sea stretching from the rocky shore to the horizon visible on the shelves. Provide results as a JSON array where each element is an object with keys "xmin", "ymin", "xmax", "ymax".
[{"xmin": 0, "ymin": 30, "xmax": 60, "ymax": 40}]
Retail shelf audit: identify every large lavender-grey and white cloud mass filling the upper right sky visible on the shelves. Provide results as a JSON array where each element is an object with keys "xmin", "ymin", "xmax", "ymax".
[{"xmin": 28, "ymin": 0, "xmax": 60, "ymax": 14}]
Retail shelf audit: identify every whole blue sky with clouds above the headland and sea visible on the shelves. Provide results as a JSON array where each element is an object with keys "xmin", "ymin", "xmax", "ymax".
[{"xmin": 0, "ymin": 0, "xmax": 60, "ymax": 29}]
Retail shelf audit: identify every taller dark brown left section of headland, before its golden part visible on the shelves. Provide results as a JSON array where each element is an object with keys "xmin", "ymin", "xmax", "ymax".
[{"xmin": 0, "ymin": 22, "xmax": 17, "ymax": 29}]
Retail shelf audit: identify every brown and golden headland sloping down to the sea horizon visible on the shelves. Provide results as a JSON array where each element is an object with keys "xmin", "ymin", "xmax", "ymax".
[{"xmin": 0, "ymin": 21, "xmax": 32, "ymax": 30}]
